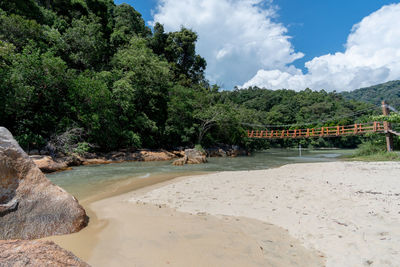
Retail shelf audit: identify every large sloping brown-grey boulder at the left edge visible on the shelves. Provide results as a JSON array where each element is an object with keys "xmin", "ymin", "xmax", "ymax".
[{"xmin": 0, "ymin": 127, "xmax": 88, "ymax": 239}]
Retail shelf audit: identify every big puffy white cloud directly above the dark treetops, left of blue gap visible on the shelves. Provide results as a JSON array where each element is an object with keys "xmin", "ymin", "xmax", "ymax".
[{"xmin": 154, "ymin": 0, "xmax": 303, "ymax": 89}]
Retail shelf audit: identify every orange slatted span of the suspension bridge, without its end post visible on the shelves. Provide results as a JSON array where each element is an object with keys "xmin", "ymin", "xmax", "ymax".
[{"xmin": 247, "ymin": 121, "xmax": 385, "ymax": 139}]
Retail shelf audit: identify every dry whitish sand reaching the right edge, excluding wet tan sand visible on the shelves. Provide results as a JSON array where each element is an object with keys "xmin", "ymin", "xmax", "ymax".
[{"xmin": 131, "ymin": 162, "xmax": 400, "ymax": 266}]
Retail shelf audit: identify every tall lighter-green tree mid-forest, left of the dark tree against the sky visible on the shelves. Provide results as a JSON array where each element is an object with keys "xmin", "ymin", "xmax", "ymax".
[{"xmin": 112, "ymin": 37, "xmax": 170, "ymax": 146}]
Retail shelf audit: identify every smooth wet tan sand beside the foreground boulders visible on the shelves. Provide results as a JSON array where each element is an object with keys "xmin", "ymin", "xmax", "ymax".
[{"xmin": 46, "ymin": 171, "xmax": 325, "ymax": 267}]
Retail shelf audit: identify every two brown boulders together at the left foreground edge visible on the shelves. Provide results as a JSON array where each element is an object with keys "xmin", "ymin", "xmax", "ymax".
[{"xmin": 0, "ymin": 127, "xmax": 88, "ymax": 266}]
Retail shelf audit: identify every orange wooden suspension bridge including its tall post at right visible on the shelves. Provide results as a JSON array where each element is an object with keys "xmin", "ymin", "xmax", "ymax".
[{"xmin": 247, "ymin": 101, "xmax": 400, "ymax": 151}]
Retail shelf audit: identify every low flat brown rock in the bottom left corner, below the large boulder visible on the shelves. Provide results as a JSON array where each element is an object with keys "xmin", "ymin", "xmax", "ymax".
[{"xmin": 0, "ymin": 240, "xmax": 89, "ymax": 267}]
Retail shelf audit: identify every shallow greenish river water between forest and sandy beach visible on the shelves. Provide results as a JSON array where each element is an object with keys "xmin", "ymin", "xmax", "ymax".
[{"xmin": 47, "ymin": 149, "xmax": 352, "ymax": 199}]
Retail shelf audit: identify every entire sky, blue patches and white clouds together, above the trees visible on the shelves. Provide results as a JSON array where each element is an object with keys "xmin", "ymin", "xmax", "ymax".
[{"xmin": 115, "ymin": 0, "xmax": 400, "ymax": 91}]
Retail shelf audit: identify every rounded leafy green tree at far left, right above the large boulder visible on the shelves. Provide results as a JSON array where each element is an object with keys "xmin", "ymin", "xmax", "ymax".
[{"xmin": 5, "ymin": 46, "xmax": 74, "ymax": 149}]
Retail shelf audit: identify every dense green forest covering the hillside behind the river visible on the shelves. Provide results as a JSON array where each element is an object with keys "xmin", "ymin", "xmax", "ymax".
[{"xmin": 0, "ymin": 0, "xmax": 394, "ymax": 154}]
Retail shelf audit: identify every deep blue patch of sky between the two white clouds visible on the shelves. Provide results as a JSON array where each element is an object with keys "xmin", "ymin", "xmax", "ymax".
[{"xmin": 275, "ymin": 0, "xmax": 395, "ymax": 71}]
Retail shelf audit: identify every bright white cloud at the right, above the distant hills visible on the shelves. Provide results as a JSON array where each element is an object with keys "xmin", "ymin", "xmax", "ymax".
[{"xmin": 243, "ymin": 4, "xmax": 400, "ymax": 91}]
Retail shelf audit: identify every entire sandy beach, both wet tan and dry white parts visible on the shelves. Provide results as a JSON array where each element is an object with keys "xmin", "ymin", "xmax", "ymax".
[{"xmin": 45, "ymin": 162, "xmax": 400, "ymax": 266}]
